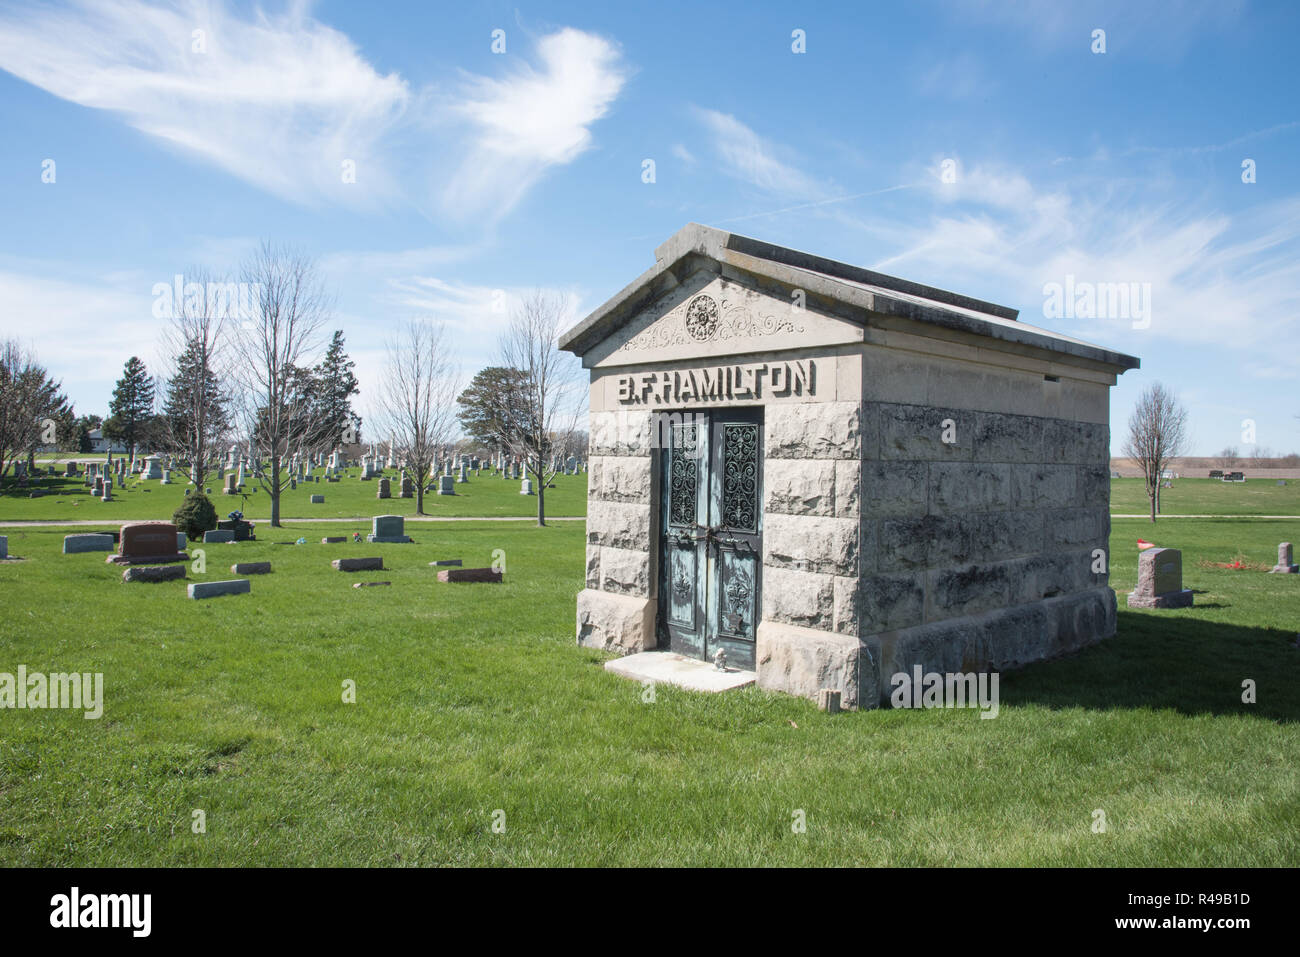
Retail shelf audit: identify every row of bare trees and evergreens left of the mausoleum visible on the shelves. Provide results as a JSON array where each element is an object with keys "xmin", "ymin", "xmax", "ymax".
[{"xmin": 0, "ymin": 237, "xmax": 585, "ymax": 525}]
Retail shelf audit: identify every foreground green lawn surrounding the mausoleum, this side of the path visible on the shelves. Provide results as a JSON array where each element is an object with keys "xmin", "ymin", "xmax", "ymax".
[{"xmin": 0, "ymin": 514, "xmax": 1300, "ymax": 866}]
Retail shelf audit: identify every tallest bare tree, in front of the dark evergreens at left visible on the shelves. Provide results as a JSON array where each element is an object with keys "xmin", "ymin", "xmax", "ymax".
[{"xmin": 230, "ymin": 242, "xmax": 330, "ymax": 528}]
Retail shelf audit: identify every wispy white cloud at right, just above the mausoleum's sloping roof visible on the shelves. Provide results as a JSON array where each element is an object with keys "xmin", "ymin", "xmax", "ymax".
[{"xmin": 872, "ymin": 166, "xmax": 1300, "ymax": 351}]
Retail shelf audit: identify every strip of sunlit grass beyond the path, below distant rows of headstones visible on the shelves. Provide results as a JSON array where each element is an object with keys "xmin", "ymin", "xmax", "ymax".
[{"xmin": 0, "ymin": 469, "xmax": 586, "ymax": 521}]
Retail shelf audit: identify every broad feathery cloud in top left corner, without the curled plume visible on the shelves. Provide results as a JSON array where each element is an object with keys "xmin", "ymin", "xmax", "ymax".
[{"xmin": 0, "ymin": 0, "xmax": 410, "ymax": 203}]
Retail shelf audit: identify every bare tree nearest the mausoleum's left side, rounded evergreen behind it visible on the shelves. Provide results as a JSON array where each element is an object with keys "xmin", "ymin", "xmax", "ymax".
[{"xmin": 501, "ymin": 291, "xmax": 581, "ymax": 525}]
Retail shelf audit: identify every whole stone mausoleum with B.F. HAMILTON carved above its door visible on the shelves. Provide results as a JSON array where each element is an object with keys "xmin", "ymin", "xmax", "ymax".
[{"xmin": 560, "ymin": 224, "xmax": 1138, "ymax": 707}]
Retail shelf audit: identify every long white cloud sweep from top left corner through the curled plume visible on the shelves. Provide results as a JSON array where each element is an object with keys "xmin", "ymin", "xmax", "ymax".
[{"xmin": 0, "ymin": 0, "xmax": 627, "ymax": 222}]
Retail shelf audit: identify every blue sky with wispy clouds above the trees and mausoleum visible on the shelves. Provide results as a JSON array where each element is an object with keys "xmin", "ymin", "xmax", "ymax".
[{"xmin": 0, "ymin": 0, "xmax": 1300, "ymax": 454}]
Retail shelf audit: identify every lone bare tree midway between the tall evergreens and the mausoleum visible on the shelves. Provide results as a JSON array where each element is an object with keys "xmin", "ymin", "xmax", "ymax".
[{"xmin": 380, "ymin": 320, "xmax": 460, "ymax": 515}]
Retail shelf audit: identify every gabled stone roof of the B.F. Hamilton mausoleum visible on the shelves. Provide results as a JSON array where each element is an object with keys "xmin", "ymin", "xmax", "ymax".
[{"xmin": 559, "ymin": 222, "xmax": 1139, "ymax": 372}]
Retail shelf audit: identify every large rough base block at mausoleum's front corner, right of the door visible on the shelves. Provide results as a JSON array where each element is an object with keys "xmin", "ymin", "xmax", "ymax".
[{"xmin": 755, "ymin": 620, "xmax": 880, "ymax": 707}]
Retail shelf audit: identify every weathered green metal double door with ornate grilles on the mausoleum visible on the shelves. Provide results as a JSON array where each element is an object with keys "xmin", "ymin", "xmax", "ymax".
[{"xmin": 658, "ymin": 408, "xmax": 763, "ymax": 671}]
